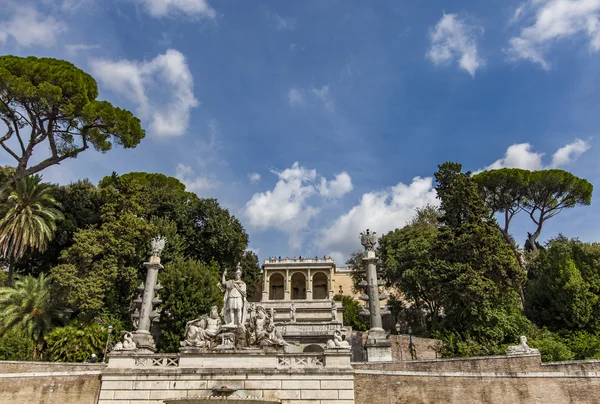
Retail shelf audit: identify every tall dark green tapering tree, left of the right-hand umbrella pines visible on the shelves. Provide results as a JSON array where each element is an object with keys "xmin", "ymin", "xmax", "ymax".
[{"xmin": 432, "ymin": 163, "xmax": 527, "ymax": 344}]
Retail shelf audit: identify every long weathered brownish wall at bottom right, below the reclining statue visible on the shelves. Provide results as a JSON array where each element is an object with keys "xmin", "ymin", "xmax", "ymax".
[{"xmin": 354, "ymin": 355, "xmax": 600, "ymax": 404}]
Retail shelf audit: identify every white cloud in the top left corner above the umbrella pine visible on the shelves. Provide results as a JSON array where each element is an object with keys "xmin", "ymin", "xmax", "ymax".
[{"xmin": 0, "ymin": 5, "xmax": 66, "ymax": 47}]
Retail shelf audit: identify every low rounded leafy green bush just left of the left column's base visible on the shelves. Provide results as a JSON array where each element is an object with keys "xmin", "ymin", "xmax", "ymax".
[{"xmin": 46, "ymin": 320, "xmax": 108, "ymax": 362}]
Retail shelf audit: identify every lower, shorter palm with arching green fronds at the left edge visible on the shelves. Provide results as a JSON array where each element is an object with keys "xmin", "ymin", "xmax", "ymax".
[{"xmin": 0, "ymin": 274, "xmax": 61, "ymax": 359}]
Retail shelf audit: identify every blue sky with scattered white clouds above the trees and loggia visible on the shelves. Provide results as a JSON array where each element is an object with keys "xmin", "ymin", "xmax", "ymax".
[{"xmin": 0, "ymin": 0, "xmax": 600, "ymax": 264}]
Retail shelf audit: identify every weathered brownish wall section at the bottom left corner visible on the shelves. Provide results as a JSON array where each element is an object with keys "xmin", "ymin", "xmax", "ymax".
[{"xmin": 0, "ymin": 361, "xmax": 105, "ymax": 404}]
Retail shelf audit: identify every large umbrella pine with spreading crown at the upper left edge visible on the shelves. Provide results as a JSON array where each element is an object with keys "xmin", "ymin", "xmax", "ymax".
[{"xmin": 0, "ymin": 56, "xmax": 145, "ymax": 188}]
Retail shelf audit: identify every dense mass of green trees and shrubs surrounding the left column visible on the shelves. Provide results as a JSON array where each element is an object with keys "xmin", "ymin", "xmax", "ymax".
[{"xmin": 0, "ymin": 173, "xmax": 260, "ymax": 361}]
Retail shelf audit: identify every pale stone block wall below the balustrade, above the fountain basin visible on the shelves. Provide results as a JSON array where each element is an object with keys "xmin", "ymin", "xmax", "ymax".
[{"xmin": 98, "ymin": 369, "xmax": 354, "ymax": 404}]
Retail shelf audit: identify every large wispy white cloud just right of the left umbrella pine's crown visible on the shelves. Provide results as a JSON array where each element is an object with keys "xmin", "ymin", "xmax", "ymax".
[{"xmin": 90, "ymin": 49, "xmax": 199, "ymax": 136}]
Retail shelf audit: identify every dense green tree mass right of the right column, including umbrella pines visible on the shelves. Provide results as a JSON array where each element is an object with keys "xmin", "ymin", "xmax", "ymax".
[{"xmin": 379, "ymin": 163, "xmax": 600, "ymax": 360}]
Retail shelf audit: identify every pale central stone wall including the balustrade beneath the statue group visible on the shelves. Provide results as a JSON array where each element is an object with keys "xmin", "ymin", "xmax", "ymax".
[{"xmin": 99, "ymin": 350, "xmax": 354, "ymax": 404}]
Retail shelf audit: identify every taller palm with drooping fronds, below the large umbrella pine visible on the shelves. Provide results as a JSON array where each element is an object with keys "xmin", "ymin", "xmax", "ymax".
[{"xmin": 0, "ymin": 175, "xmax": 63, "ymax": 286}]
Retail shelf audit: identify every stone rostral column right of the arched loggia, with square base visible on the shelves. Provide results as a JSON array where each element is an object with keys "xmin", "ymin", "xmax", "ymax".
[{"xmin": 360, "ymin": 229, "xmax": 392, "ymax": 362}]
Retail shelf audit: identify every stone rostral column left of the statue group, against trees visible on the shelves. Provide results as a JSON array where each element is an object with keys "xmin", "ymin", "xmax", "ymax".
[{"xmin": 133, "ymin": 237, "xmax": 165, "ymax": 352}]
